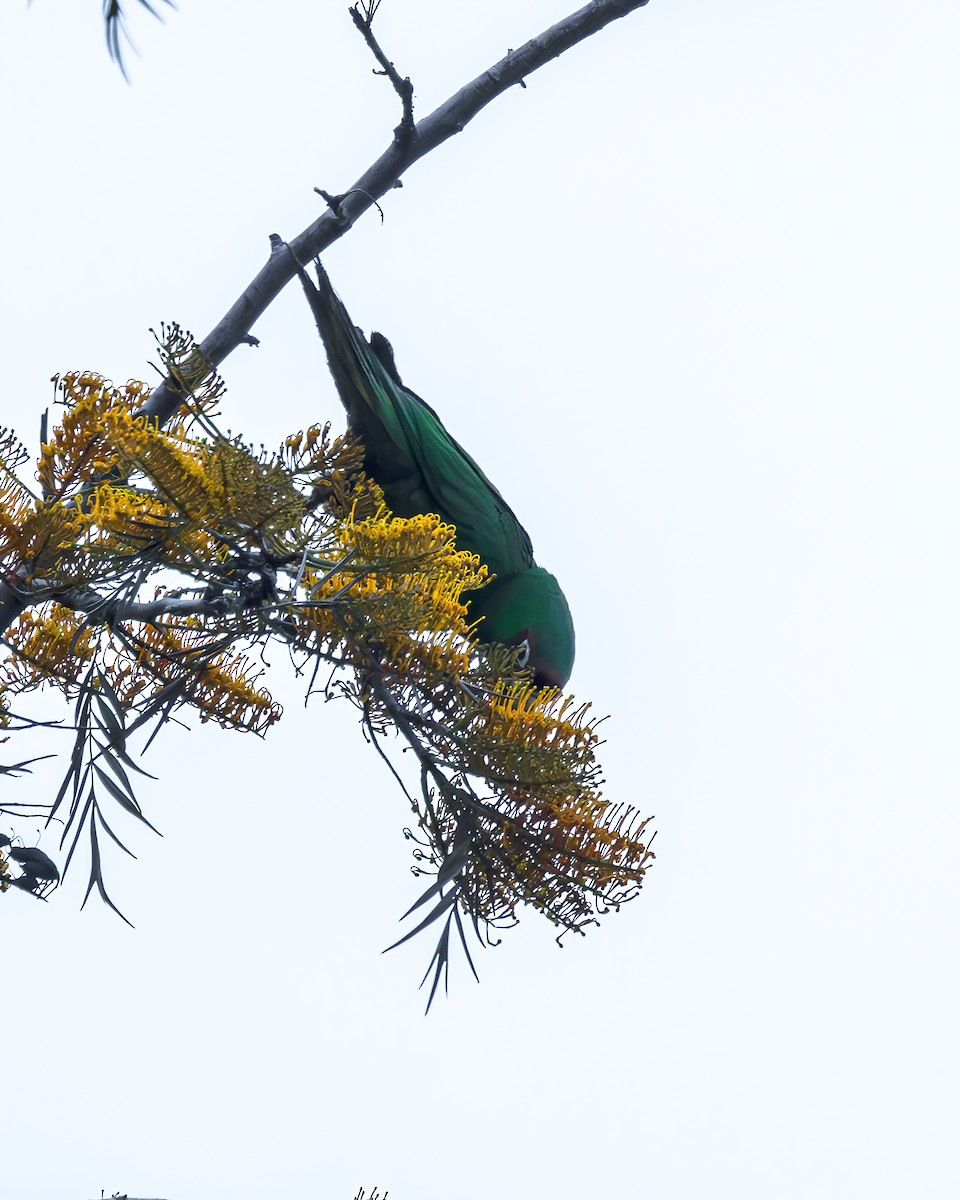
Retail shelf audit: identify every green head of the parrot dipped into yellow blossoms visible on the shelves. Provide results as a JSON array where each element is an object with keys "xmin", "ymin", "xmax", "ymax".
[{"xmin": 470, "ymin": 566, "xmax": 575, "ymax": 688}]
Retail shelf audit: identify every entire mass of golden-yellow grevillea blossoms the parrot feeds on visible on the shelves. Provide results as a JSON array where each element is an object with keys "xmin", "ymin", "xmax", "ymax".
[{"xmin": 0, "ymin": 355, "xmax": 653, "ymax": 970}]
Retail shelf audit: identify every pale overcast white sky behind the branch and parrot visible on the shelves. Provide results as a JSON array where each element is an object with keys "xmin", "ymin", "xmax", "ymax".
[{"xmin": 0, "ymin": 0, "xmax": 960, "ymax": 1200}]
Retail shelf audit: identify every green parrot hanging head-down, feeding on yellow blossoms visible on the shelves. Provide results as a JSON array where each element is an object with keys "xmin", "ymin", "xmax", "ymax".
[{"xmin": 301, "ymin": 263, "xmax": 574, "ymax": 688}]
